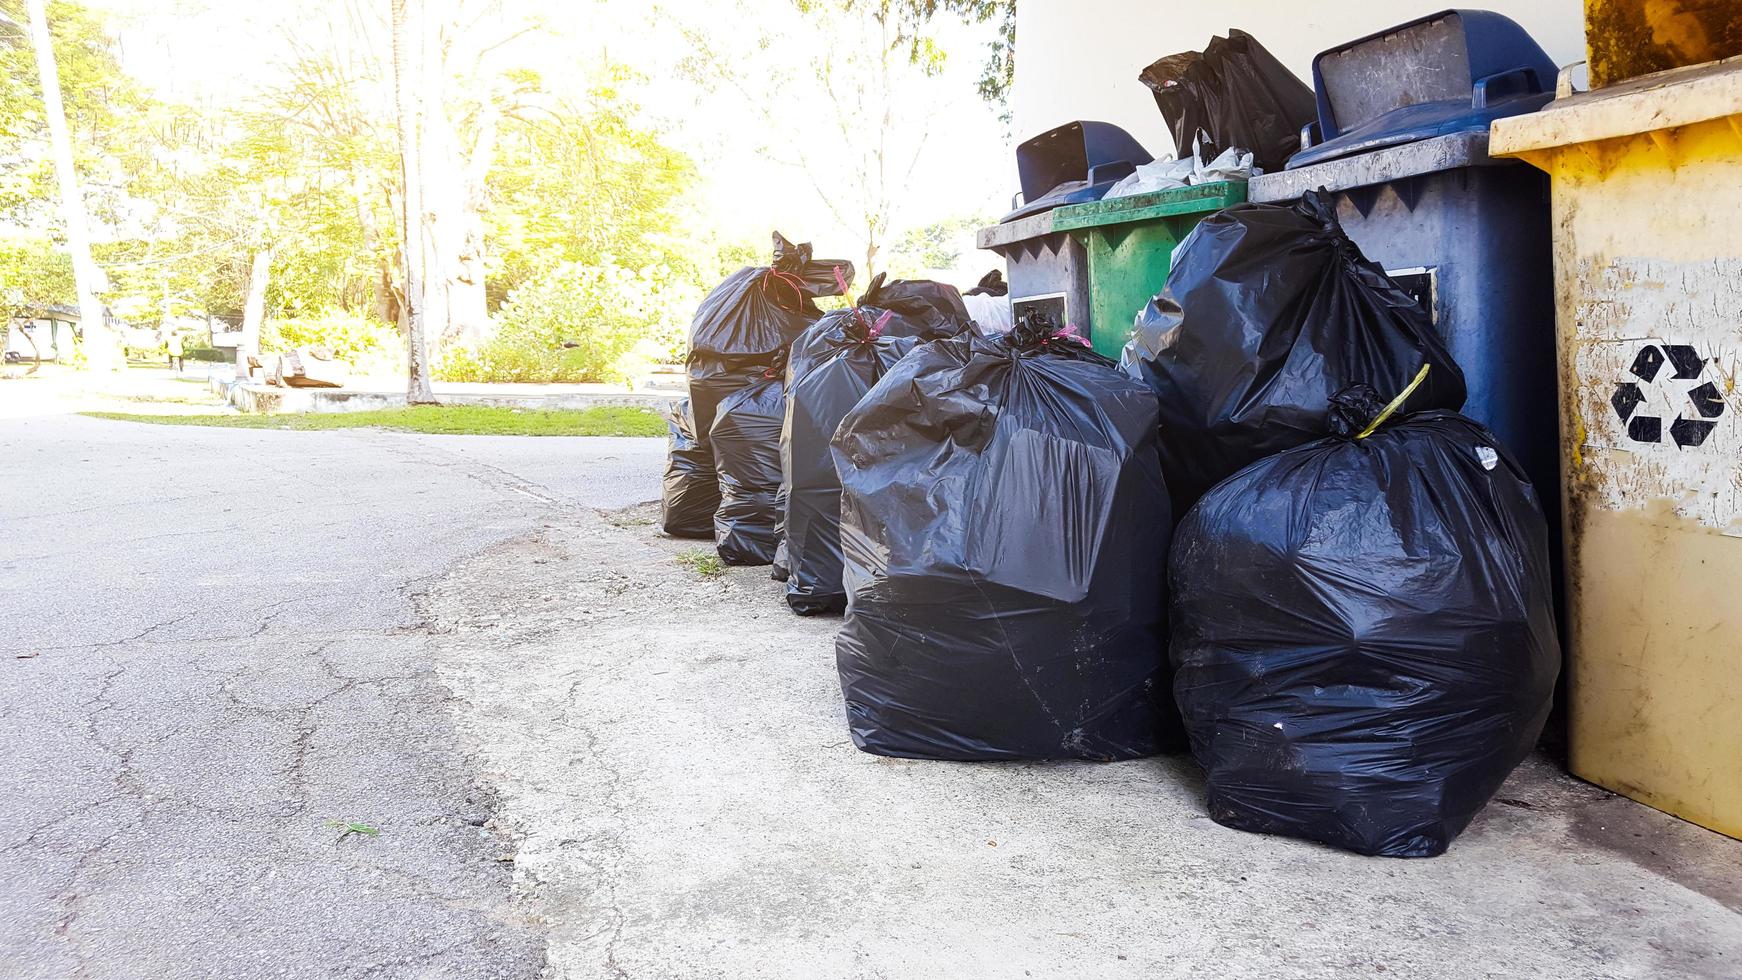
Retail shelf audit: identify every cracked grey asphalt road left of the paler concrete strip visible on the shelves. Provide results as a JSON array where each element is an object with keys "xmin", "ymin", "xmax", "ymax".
[{"xmin": 0, "ymin": 416, "xmax": 664, "ymax": 978}]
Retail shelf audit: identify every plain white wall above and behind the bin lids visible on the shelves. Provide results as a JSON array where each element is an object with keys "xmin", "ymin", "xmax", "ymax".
[{"xmin": 1014, "ymin": 0, "xmax": 1585, "ymax": 157}]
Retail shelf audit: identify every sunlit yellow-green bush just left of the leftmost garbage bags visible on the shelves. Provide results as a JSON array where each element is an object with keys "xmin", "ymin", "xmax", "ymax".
[{"xmin": 437, "ymin": 263, "xmax": 699, "ymax": 383}]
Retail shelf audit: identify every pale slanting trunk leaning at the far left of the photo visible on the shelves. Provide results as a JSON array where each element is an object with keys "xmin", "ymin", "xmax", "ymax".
[{"xmin": 26, "ymin": 0, "xmax": 127, "ymax": 371}]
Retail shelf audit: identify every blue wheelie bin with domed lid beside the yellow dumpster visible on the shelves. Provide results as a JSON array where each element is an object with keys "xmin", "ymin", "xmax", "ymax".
[{"xmin": 1247, "ymin": 10, "xmax": 1561, "ymax": 536}]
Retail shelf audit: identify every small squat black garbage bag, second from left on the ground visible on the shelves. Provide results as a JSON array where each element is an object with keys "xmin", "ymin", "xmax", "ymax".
[{"xmin": 711, "ymin": 366, "xmax": 786, "ymax": 566}]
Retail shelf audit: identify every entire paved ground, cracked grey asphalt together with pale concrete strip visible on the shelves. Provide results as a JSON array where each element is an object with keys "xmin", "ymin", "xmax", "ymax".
[{"xmin": 0, "ymin": 402, "xmax": 1742, "ymax": 980}]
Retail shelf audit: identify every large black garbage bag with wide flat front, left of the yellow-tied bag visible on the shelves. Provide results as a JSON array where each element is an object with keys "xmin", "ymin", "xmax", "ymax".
[{"xmin": 834, "ymin": 317, "xmax": 1181, "ymax": 759}]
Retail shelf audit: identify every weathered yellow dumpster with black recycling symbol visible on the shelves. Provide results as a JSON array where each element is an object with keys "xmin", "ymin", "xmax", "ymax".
[{"xmin": 1489, "ymin": 59, "xmax": 1742, "ymax": 837}]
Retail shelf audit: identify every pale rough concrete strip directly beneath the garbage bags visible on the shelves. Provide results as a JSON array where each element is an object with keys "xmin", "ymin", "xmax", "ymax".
[{"xmin": 422, "ymin": 508, "xmax": 1742, "ymax": 980}]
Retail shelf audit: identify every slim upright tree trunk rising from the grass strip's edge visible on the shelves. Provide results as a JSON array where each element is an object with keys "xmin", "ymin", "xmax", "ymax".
[{"xmin": 392, "ymin": 0, "xmax": 441, "ymax": 406}]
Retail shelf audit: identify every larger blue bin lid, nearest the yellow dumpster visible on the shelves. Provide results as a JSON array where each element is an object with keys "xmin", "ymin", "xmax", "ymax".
[{"xmin": 1287, "ymin": 10, "xmax": 1557, "ymax": 171}]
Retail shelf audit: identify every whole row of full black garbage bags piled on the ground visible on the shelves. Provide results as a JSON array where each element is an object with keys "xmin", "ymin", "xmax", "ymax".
[{"xmin": 665, "ymin": 195, "xmax": 1561, "ymax": 856}]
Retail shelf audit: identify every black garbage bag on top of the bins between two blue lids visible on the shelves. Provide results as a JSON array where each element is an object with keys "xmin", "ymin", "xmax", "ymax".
[{"xmin": 1138, "ymin": 31, "xmax": 1319, "ymax": 172}]
